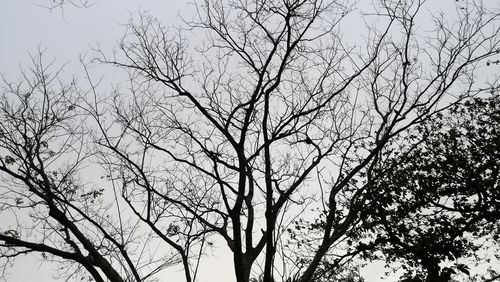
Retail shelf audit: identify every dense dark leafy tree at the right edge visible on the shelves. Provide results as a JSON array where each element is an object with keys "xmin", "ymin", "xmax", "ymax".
[{"xmin": 362, "ymin": 95, "xmax": 500, "ymax": 281}]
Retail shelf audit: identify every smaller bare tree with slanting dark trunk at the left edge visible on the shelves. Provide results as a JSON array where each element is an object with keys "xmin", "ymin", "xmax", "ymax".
[{"xmin": 0, "ymin": 51, "xmax": 188, "ymax": 281}]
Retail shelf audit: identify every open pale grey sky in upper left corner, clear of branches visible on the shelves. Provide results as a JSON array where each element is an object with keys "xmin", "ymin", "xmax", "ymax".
[{"xmin": 0, "ymin": 0, "xmax": 188, "ymax": 74}]
